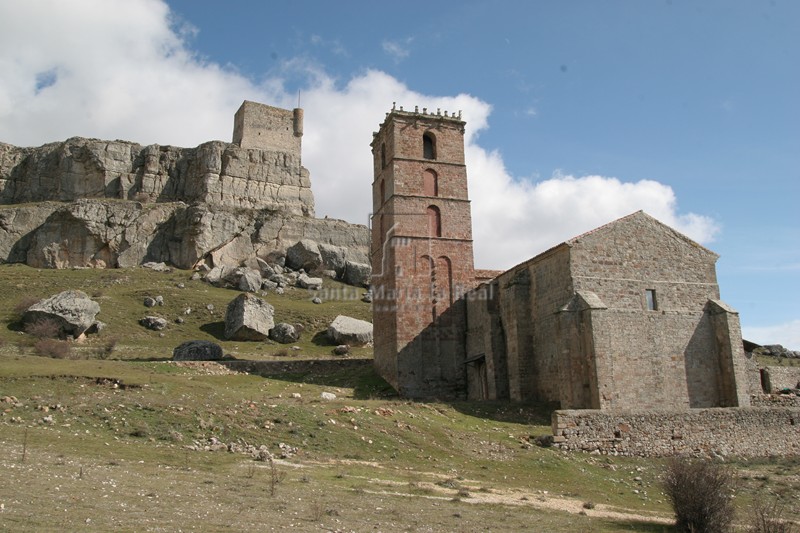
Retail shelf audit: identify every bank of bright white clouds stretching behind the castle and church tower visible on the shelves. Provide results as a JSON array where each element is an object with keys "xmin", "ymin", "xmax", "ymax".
[{"xmin": 0, "ymin": 0, "xmax": 717, "ymax": 268}]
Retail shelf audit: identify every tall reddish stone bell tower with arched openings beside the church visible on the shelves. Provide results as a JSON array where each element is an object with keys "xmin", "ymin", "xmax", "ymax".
[{"xmin": 371, "ymin": 107, "xmax": 475, "ymax": 398}]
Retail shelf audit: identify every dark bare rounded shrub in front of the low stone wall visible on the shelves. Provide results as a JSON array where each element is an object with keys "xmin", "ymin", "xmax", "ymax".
[{"xmin": 663, "ymin": 458, "xmax": 734, "ymax": 533}]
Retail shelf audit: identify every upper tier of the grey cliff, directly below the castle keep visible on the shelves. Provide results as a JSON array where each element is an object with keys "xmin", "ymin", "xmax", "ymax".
[{"xmin": 0, "ymin": 137, "xmax": 314, "ymax": 216}]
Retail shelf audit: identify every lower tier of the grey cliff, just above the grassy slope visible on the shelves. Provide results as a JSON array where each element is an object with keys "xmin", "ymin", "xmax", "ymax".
[{"xmin": 0, "ymin": 199, "xmax": 369, "ymax": 268}]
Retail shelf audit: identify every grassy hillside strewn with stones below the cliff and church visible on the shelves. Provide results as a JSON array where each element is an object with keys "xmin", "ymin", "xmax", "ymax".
[{"xmin": 0, "ymin": 266, "xmax": 800, "ymax": 532}]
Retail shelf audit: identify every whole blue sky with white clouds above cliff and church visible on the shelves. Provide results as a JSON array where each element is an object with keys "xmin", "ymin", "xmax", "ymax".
[{"xmin": 0, "ymin": 0, "xmax": 800, "ymax": 349}]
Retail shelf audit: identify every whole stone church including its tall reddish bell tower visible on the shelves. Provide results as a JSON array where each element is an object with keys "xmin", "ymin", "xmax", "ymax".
[{"xmin": 370, "ymin": 107, "xmax": 749, "ymax": 410}]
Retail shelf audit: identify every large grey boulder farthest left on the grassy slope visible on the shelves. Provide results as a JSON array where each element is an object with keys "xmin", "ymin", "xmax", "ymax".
[{"xmin": 22, "ymin": 291, "xmax": 100, "ymax": 338}]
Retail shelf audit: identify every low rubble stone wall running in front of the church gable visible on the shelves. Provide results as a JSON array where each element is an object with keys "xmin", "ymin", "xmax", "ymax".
[{"xmin": 552, "ymin": 407, "xmax": 800, "ymax": 457}]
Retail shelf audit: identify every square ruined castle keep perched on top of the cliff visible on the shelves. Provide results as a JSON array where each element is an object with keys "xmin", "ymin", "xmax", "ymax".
[{"xmin": 233, "ymin": 100, "xmax": 303, "ymax": 157}]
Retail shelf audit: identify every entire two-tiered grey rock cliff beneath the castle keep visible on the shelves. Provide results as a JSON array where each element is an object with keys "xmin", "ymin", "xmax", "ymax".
[{"xmin": 0, "ymin": 137, "xmax": 369, "ymax": 268}]
